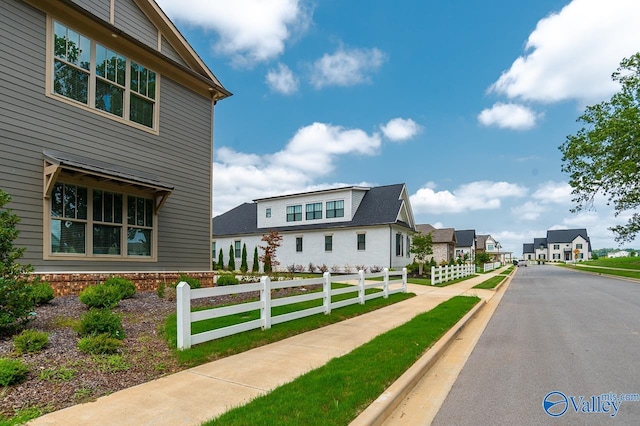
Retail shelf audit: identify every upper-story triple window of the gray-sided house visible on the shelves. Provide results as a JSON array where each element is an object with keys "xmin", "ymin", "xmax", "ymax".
[{"xmin": 51, "ymin": 21, "xmax": 158, "ymax": 129}]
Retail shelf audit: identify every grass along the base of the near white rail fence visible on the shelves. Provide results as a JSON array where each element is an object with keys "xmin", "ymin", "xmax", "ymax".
[{"xmin": 164, "ymin": 283, "xmax": 415, "ymax": 367}]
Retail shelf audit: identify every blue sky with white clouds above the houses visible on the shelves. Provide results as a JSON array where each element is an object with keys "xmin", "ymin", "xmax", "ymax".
[{"xmin": 157, "ymin": 0, "xmax": 640, "ymax": 256}]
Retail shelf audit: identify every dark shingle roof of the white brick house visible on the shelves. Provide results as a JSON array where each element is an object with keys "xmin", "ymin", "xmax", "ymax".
[{"xmin": 213, "ymin": 184, "xmax": 411, "ymax": 237}]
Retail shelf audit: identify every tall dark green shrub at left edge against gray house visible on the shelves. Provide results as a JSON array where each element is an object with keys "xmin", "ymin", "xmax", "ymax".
[{"xmin": 0, "ymin": 189, "xmax": 35, "ymax": 334}]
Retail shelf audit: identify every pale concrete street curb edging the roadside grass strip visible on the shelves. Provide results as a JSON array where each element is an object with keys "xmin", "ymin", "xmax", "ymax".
[{"xmin": 350, "ymin": 299, "xmax": 486, "ymax": 426}]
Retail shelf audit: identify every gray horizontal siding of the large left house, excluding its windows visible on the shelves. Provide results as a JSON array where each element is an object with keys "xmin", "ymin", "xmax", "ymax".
[{"xmin": 0, "ymin": 0, "xmax": 211, "ymax": 272}]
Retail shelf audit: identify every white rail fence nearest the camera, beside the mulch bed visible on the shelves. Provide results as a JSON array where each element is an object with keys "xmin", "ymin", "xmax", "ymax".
[{"xmin": 176, "ymin": 268, "xmax": 407, "ymax": 350}]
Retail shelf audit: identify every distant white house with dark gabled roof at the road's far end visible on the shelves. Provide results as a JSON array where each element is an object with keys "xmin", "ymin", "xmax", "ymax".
[{"xmin": 523, "ymin": 228, "xmax": 591, "ymax": 262}]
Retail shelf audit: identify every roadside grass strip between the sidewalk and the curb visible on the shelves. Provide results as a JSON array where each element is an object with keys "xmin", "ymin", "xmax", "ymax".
[{"xmin": 204, "ymin": 296, "xmax": 480, "ymax": 426}]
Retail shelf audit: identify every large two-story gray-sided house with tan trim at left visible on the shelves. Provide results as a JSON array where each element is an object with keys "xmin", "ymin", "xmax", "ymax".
[{"xmin": 0, "ymin": 0, "xmax": 231, "ymax": 273}]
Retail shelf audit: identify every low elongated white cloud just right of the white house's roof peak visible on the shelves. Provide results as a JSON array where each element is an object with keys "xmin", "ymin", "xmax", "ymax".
[{"xmin": 410, "ymin": 181, "xmax": 526, "ymax": 214}]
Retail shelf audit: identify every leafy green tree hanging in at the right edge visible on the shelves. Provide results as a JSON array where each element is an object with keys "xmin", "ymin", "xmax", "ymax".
[{"xmin": 560, "ymin": 53, "xmax": 640, "ymax": 242}]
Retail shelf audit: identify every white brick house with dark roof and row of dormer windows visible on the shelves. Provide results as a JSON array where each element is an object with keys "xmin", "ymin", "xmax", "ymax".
[{"xmin": 212, "ymin": 184, "xmax": 416, "ymax": 272}]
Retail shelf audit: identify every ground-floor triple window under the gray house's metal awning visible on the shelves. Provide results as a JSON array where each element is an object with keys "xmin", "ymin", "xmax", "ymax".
[{"xmin": 50, "ymin": 182, "xmax": 155, "ymax": 258}]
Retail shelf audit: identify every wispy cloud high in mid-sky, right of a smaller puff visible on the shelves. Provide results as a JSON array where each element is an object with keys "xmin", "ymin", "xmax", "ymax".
[{"xmin": 311, "ymin": 47, "xmax": 386, "ymax": 89}]
